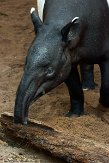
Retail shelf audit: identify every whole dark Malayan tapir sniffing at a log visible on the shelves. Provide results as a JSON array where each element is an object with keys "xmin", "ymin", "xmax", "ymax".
[{"xmin": 14, "ymin": 0, "xmax": 109, "ymax": 124}]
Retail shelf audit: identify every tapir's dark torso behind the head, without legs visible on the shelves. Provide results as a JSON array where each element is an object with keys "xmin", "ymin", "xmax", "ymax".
[{"xmin": 44, "ymin": 0, "xmax": 109, "ymax": 64}]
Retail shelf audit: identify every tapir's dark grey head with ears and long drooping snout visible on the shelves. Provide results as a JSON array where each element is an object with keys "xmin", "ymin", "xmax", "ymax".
[{"xmin": 14, "ymin": 9, "xmax": 80, "ymax": 124}]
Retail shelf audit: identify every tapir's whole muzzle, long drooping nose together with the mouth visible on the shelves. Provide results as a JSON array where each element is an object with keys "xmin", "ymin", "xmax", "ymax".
[{"xmin": 14, "ymin": 72, "xmax": 46, "ymax": 124}]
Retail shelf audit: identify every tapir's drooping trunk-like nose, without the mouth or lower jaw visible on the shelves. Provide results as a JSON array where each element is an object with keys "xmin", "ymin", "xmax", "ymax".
[{"xmin": 14, "ymin": 72, "xmax": 37, "ymax": 124}]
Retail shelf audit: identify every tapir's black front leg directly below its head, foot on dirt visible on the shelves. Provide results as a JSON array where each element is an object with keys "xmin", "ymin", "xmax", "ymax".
[{"xmin": 65, "ymin": 66, "xmax": 84, "ymax": 117}]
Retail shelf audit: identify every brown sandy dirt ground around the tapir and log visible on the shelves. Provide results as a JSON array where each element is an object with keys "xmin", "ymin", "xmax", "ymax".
[{"xmin": 0, "ymin": 0, "xmax": 109, "ymax": 163}]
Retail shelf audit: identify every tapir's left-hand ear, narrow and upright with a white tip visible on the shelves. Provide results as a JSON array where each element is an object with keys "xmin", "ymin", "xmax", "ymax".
[{"xmin": 30, "ymin": 7, "xmax": 42, "ymax": 33}]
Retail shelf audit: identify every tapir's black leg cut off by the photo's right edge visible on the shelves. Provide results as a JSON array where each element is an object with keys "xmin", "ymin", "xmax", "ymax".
[{"xmin": 99, "ymin": 60, "xmax": 109, "ymax": 107}]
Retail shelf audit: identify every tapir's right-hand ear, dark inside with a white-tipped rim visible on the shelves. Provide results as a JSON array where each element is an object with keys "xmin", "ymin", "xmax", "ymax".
[{"xmin": 61, "ymin": 17, "xmax": 81, "ymax": 49}]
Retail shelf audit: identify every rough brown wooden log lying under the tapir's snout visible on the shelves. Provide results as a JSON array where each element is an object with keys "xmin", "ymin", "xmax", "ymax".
[{"xmin": 0, "ymin": 113, "xmax": 109, "ymax": 163}]
